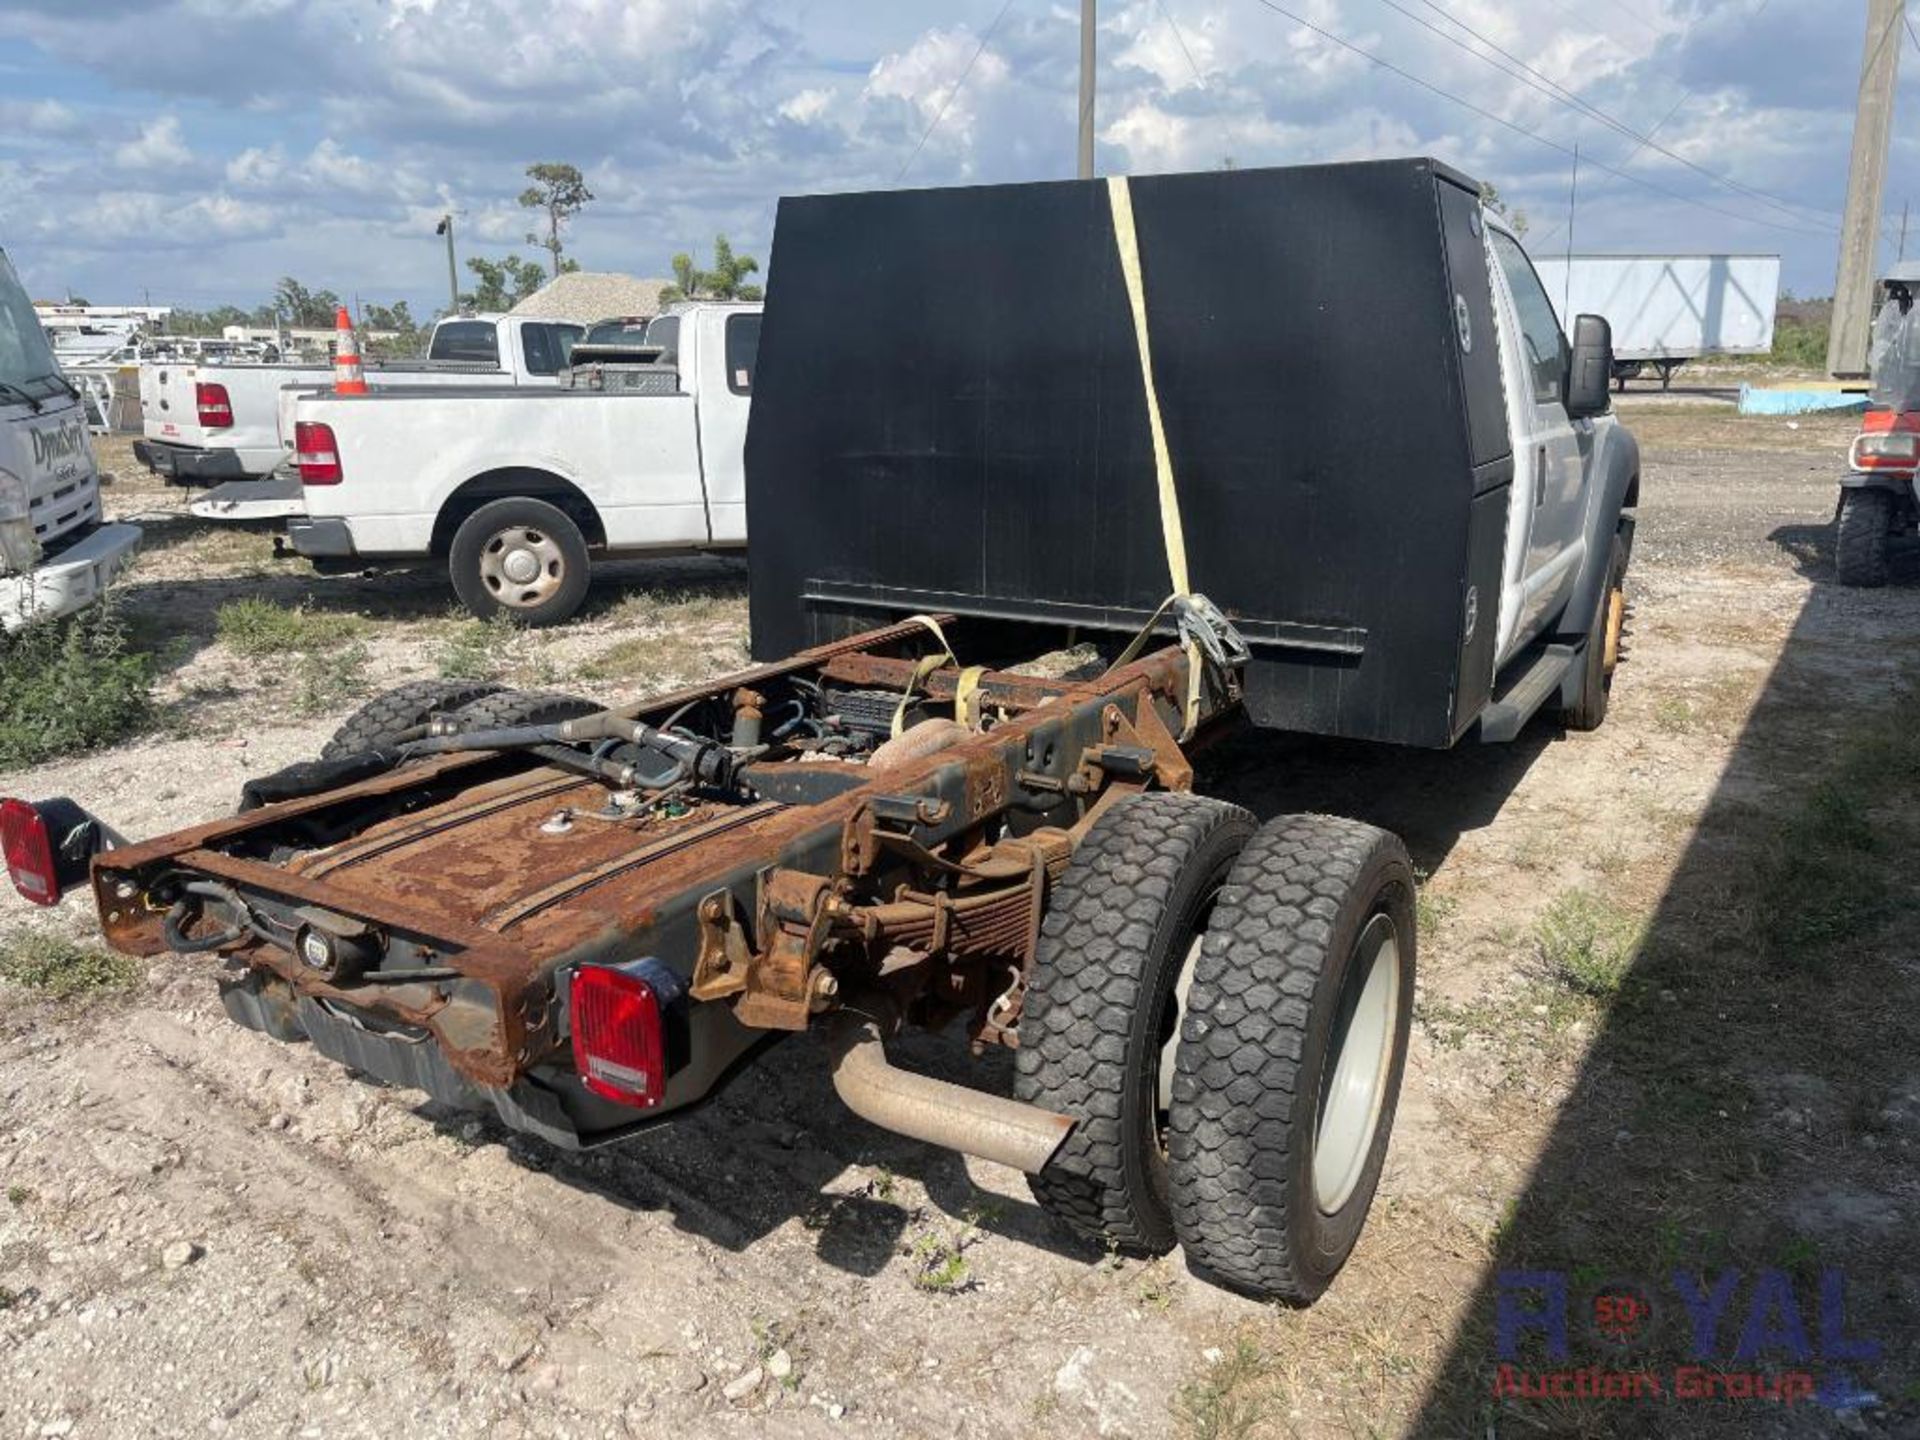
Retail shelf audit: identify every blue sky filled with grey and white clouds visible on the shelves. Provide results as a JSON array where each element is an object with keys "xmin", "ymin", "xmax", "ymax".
[{"xmin": 0, "ymin": 0, "xmax": 1920, "ymax": 313}]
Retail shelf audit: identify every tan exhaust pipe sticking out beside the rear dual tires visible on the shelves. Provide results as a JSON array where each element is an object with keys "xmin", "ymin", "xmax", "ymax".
[{"xmin": 828, "ymin": 1000, "xmax": 1073, "ymax": 1175}]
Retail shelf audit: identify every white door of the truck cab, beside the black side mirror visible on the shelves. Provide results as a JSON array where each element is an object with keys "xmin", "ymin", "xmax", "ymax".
[{"xmin": 1488, "ymin": 227, "xmax": 1594, "ymax": 660}]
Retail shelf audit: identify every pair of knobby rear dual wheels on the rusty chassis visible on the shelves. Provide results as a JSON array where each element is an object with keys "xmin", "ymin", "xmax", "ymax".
[{"xmin": 1016, "ymin": 795, "xmax": 1415, "ymax": 1304}]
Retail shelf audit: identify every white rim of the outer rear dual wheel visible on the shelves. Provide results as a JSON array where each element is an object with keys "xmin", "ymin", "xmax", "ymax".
[{"xmin": 1313, "ymin": 914, "xmax": 1400, "ymax": 1215}]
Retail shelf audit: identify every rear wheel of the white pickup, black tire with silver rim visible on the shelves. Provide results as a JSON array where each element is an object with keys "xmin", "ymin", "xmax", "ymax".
[{"xmin": 447, "ymin": 497, "xmax": 589, "ymax": 626}]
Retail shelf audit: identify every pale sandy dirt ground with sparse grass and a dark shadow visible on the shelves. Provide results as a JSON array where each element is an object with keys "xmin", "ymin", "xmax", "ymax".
[{"xmin": 0, "ymin": 407, "xmax": 1920, "ymax": 1438}]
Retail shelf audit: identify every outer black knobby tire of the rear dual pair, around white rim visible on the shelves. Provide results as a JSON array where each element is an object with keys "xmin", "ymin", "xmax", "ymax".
[{"xmin": 1169, "ymin": 814, "xmax": 1415, "ymax": 1304}]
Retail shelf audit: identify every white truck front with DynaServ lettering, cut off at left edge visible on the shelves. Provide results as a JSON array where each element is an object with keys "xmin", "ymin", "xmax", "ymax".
[{"xmin": 0, "ymin": 250, "xmax": 140, "ymax": 630}]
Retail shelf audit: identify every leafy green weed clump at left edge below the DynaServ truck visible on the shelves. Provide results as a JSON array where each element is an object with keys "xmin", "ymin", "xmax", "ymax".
[{"xmin": 0, "ymin": 597, "xmax": 154, "ymax": 770}]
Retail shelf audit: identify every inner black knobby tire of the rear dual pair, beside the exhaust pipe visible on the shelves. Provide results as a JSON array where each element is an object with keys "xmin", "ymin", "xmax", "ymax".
[{"xmin": 1014, "ymin": 793, "xmax": 1254, "ymax": 1254}]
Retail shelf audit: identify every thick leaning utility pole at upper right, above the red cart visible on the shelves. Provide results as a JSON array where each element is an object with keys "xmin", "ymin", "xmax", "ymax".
[{"xmin": 1826, "ymin": 0, "xmax": 1907, "ymax": 378}]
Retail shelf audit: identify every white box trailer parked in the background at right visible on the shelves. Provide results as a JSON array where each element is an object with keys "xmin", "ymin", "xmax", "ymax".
[{"xmin": 1532, "ymin": 255, "xmax": 1780, "ymax": 390}]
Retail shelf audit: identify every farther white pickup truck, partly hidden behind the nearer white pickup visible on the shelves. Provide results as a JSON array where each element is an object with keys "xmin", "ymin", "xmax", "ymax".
[{"xmin": 132, "ymin": 315, "xmax": 582, "ymax": 484}]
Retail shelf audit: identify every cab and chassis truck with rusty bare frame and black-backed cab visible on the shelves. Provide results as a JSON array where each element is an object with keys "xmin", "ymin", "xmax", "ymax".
[{"xmin": 0, "ymin": 159, "xmax": 1638, "ymax": 1302}]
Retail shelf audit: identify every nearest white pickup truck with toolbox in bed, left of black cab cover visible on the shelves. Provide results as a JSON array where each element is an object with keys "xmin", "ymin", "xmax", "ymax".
[{"xmin": 286, "ymin": 303, "xmax": 760, "ymax": 626}]
